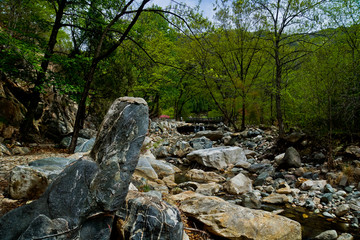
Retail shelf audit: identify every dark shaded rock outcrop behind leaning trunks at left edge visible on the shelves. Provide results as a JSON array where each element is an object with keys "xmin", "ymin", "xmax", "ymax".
[{"xmin": 0, "ymin": 75, "xmax": 92, "ymax": 143}]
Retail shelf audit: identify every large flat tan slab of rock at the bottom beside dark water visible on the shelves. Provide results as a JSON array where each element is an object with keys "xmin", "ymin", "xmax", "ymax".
[{"xmin": 172, "ymin": 192, "xmax": 301, "ymax": 240}]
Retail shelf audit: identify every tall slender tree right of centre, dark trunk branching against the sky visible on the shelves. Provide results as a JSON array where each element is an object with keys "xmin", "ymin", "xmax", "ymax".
[{"xmin": 252, "ymin": 0, "xmax": 325, "ymax": 137}]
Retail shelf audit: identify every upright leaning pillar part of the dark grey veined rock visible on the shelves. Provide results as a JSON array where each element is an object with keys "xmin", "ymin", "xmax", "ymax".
[{"xmin": 90, "ymin": 97, "xmax": 149, "ymax": 211}]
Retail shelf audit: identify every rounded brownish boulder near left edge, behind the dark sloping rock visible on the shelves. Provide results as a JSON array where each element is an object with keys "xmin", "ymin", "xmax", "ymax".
[{"xmin": 9, "ymin": 166, "xmax": 48, "ymax": 200}]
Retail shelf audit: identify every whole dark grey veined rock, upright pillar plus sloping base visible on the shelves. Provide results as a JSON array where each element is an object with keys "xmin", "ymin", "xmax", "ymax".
[{"xmin": 0, "ymin": 98, "xmax": 149, "ymax": 240}]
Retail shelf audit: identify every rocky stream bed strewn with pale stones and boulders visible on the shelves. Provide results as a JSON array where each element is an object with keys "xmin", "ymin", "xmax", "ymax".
[{"xmin": 3, "ymin": 107, "xmax": 360, "ymax": 239}]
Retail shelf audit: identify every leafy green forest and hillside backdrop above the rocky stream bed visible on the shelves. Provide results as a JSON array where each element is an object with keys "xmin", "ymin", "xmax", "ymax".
[{"xmin": 0, "ymin": 0, "xmax": 360, "ymax": 147}]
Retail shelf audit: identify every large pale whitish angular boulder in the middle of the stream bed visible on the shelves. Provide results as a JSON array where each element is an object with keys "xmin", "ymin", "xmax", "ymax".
[{"xmin": 187, "ymin": 147, "xmax": 246, "ymax": 169}]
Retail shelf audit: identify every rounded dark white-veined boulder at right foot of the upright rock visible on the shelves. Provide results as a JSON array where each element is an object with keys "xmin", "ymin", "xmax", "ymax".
[{"xmin": 116, "ymin": 191, "xmax": 183, "ymax": 240}]
